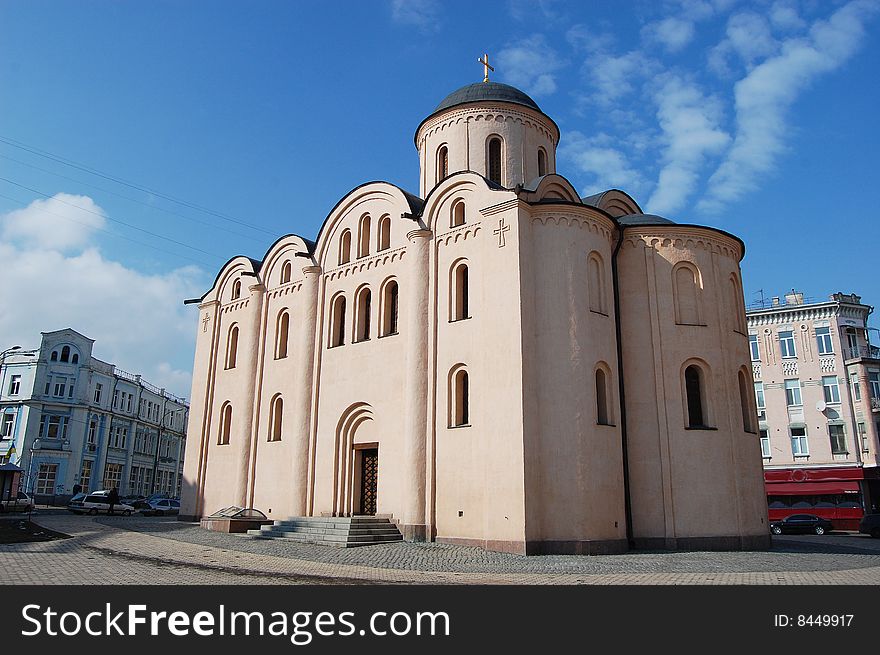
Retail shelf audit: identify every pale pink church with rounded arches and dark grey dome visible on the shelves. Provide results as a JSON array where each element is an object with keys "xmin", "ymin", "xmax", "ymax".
[{"xmin": 181, "ymin": 70, "xmax": 769, "ymax": 554}]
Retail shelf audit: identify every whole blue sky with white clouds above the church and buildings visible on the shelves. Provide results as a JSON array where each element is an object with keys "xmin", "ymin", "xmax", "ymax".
[{"xmin": 0, "ymin": 0, "xmax": 880, "ymax": 396}]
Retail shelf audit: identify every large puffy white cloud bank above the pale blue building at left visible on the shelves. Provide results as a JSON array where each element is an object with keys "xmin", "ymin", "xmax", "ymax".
[{"xmin": 0, "ymin": 194, "xmax": 206, "ymax": 397}]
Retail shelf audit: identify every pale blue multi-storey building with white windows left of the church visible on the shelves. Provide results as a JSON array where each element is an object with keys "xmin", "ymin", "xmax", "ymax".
[{"xmin": 0, "ymin": 328, "xmax": 189, "ymax": 503}]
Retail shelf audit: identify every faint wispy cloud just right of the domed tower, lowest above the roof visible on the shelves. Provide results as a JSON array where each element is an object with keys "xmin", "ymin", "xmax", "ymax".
[{"xmin": 560, "ymin": 132, "xmax": 645, "ymax": 196}]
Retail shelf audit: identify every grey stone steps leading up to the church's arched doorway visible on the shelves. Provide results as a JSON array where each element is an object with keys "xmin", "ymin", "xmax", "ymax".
[{"xmin": 247, "ymin": 516, "xmax": 403, "ymax": 548}]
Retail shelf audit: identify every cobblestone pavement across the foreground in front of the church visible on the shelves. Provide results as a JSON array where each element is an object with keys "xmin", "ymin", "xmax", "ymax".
[{"xmin": 0, "ymin": 515, "xmax": 880, "ymax": 585}]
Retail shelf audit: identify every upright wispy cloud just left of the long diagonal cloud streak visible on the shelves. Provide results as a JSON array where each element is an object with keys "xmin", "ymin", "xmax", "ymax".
[{"xmin": 647, "ymin": 76, "xmax": 730, "ymax": 214}]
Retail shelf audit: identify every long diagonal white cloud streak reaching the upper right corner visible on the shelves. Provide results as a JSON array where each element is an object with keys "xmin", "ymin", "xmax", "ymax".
[{"xmin": 698, "ymin": 0, "xmax": 878, "ymax": 212}]
